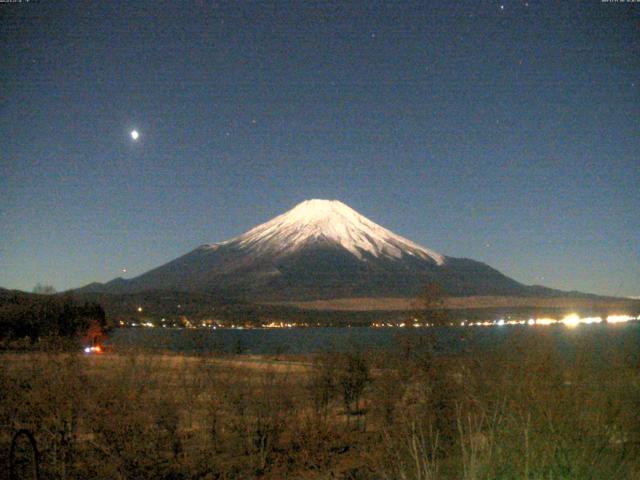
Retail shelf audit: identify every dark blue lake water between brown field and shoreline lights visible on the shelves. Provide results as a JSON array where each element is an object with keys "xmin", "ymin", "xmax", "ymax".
[{"xmin": 108, "ymin": 322, "xmax": 640, "ymax": 355}]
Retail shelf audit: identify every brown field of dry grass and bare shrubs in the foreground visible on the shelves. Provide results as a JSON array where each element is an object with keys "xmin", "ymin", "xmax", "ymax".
[{"xmin": 0, "ymin": 329, "xmax": 640, "ymax": 480}]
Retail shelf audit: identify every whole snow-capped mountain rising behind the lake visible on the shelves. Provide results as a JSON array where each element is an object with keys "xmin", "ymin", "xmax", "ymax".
[{"xmin": 78, "ymin": 200, "xmax": 560, "ymax": 301}]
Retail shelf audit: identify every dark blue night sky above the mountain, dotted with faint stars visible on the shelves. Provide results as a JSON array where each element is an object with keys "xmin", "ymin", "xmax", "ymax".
[{"xmin": 0, "ymin": 0, "xmax": 640, "ymax": 295}]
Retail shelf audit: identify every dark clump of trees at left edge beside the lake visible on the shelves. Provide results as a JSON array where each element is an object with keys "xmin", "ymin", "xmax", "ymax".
[{"xmin": 0, "ymin": 295, "xmax": 106, "ymax": 342}]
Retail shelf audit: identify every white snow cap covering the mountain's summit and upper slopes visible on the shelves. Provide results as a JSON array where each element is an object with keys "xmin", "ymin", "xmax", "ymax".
[{"xmin": 208, "ymin": 199, "xmax": 445, "ymax": 265}]
